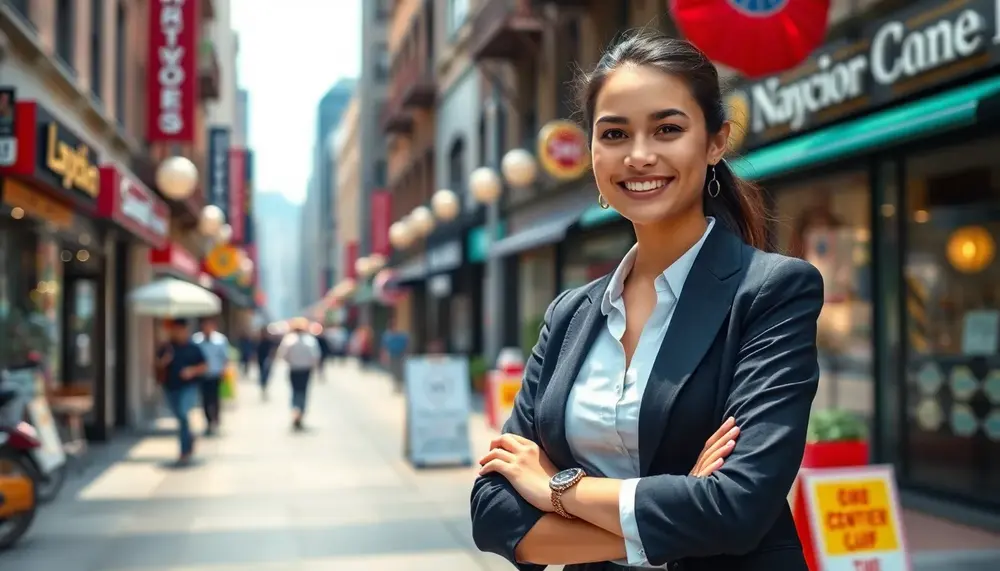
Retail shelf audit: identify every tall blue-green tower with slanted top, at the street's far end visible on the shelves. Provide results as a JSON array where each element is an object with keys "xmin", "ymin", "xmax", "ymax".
[{"xmin": 302, "ymin": 78, "xmax": 357, "ymax": 304}]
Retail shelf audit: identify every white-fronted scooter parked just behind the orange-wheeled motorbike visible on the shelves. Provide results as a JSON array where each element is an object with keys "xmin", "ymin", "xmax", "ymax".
[{"xmin": 0, "ymin": 368, "xmax": 69, "ymax": 504}]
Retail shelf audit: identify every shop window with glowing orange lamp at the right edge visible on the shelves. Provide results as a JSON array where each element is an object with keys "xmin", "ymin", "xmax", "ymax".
[{"xmin": 902, "ymin": 138, "xmax": 1000, "ymax": 505}]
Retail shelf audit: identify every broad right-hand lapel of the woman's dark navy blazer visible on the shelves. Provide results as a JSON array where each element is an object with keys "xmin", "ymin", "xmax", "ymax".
[{"xmin": 639, "ymin": 225, "xmax": 742, "ymax": 476}]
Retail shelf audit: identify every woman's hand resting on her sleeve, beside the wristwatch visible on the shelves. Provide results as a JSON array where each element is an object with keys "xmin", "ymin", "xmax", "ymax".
[{"xmin": 479, "ymin": 434, "xmax": 558, "ymax": 512}]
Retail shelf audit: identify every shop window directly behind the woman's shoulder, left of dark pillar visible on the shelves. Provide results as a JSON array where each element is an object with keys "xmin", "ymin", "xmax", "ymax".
[{"xmin": 772, "ymin": 171, "xmax": 875, "ymax": 424}]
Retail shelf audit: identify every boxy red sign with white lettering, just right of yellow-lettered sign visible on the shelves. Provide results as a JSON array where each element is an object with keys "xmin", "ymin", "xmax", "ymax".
[{"xmin": 97, "ymin": 164, "xmax": 170, "ymax": 248}]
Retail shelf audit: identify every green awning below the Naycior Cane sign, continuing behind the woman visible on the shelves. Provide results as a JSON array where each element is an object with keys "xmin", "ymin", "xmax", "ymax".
[{"xmin": 580, "ymin": 77, "xmax": 1000, "ymax": 228}]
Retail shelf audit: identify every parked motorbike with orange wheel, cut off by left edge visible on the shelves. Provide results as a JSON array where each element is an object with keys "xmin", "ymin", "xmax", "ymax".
[{"xmin": 0, "ymin": 390, "xmax": 41, "ymax": 550}]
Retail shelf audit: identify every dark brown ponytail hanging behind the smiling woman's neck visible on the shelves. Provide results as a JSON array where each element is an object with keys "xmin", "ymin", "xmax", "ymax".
[{"xmin": 703, "ymin": 160, "xmax": 772, "ymax": 251}]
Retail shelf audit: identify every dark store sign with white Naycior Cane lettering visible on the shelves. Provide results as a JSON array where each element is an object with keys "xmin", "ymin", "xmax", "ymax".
[{"xmin": 728, "ymin": 0, "xmax": 1000, "ymax": 147}]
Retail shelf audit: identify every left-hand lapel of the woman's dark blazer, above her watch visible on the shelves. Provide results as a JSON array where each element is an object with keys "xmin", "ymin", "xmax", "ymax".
[{"xmin": 538, "ymin": 276, "xmax": 611, "ymax": 469}]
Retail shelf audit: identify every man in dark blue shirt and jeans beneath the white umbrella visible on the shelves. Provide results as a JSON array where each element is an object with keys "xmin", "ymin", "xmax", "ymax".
[{"xmin": 156, "ymin": 320, "xmax": 208, "ymax": 465}]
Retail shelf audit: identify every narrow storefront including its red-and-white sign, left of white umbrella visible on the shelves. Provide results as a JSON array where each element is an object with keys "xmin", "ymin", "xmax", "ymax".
[{"xmin": 97, "ymin": 164, "xmax": 170, "ymax": 427}]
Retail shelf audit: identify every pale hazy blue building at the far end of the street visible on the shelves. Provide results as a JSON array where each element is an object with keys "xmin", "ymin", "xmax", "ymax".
[{"xmin": 254, "ymin": 192, "xmax": 302, "ymax": 319}]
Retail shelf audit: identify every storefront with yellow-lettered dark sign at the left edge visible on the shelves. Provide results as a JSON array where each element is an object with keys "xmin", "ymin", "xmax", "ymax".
[{"xmin": 0, "ymin": 101, "xmax": 117, "ymax": 440}]
